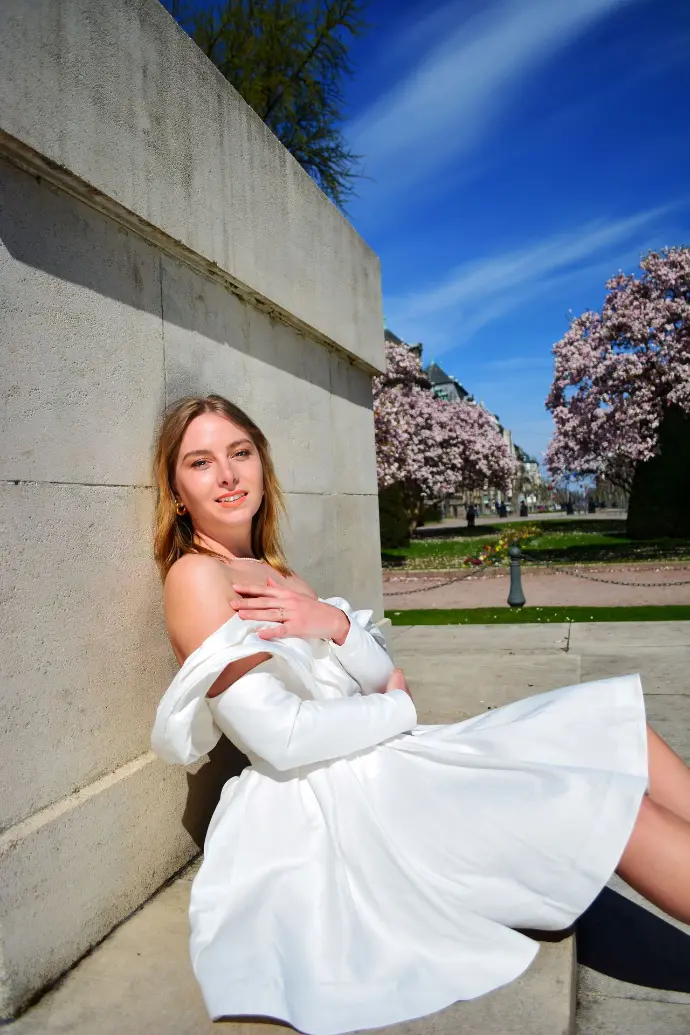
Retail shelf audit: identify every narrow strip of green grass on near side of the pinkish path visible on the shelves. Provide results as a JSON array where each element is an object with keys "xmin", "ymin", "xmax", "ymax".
[{"xmin": 386, "ymin": 604, "xmax": 690, "ymax": 625}]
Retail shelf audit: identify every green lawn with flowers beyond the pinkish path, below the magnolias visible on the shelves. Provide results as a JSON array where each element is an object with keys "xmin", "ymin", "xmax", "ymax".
[{"xmin": 382, "ymin": 518, "xmax": 690, "ymax": 570}]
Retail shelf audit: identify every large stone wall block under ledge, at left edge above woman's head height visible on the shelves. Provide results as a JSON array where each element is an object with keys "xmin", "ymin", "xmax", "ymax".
[{"xmin": 0, "ymin": 158, "xmax": 163, "ymax": 485}]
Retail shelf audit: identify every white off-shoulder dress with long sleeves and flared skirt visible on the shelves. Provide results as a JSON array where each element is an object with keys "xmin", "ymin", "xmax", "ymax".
[{"xmin": 152, "ymin": 597, "xmax": 648, "ymax": 1035}]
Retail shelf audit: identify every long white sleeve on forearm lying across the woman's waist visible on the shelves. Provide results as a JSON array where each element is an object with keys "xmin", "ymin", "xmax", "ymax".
[{"xmin": 208, "ymin": 670, "xmax": 417, "ymax": 770}]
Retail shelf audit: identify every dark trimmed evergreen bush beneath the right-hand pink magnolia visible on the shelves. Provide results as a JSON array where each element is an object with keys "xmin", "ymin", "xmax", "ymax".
[{"xmin": 627, "ymin": 406, "xmax": 690, "ymax": 539}]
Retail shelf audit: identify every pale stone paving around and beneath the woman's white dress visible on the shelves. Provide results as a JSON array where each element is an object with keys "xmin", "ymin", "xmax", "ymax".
[{"xmin": 4, "ymin": 622, "xmax": 690, "ymax": 1035}]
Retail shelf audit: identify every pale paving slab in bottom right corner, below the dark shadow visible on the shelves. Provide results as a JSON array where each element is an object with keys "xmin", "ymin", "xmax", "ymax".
[{"xmin": 575, "ymin": 995, "xmax": 690, "ymax": 1035}]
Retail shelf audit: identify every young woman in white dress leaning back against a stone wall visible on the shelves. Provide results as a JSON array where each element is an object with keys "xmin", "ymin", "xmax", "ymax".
[{"xmin": 152, "ymin": 395, "xmax": 690, "ymax": 1035}]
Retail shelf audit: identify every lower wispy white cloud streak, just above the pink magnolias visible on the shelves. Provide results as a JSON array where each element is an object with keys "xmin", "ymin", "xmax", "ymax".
[{"xmin": 385, "ymin": 206, "xmax": 668, "ymax": 353}]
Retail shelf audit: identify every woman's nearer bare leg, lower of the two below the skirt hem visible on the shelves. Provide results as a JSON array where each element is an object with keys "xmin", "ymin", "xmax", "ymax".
[{"xmin": 617, "ymin": 795, "xmax": 690, "ymax": 923}]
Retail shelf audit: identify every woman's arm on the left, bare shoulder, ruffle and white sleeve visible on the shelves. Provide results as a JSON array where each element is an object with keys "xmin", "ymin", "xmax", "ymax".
[{"xmin": 152, "ymin": 557, "xmax": 417, "ymax": 769}]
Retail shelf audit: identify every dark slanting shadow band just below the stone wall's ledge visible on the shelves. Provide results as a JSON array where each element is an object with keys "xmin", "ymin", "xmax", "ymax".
[{"xmin": 0, "ymin": 159, "xmax": 371, "ymax": 410}]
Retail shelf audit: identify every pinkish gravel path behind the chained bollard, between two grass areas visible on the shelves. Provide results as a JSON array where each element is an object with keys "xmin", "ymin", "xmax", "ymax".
[{"xmin": 384, "ymin": 564, "xmax": 690, "ymax": 611}]
